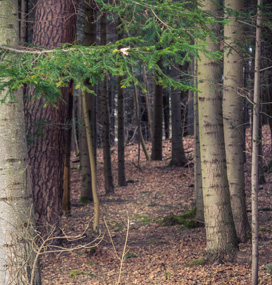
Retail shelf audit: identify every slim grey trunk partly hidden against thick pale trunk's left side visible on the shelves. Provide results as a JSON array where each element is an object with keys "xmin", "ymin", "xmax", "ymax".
[{"xmin": 194, "ymin": 60, "xmax": 204, "ymax": 222}]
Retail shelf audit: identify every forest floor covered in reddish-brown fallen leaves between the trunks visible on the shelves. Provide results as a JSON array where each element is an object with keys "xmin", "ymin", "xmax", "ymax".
[{"xmin": 41, "ymin": 127, "xmax": 272, "ymax": 285}]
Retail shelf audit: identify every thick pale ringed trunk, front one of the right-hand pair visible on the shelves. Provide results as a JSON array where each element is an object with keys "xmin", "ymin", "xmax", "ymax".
[{"xmin": 198, "ymin": 0, "xmax": 237, "ymax": 262}]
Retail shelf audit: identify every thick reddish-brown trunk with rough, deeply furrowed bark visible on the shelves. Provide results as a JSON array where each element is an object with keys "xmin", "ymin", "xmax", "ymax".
[{"xmin": 25, "ymin": 0, "xmax": 76, "ymax": 236}]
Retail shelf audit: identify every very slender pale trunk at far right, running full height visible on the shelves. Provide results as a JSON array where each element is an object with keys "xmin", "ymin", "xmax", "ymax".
[{"xmin": 251, "ymin": 0, "xmax": 262, "ymax": 285}]
